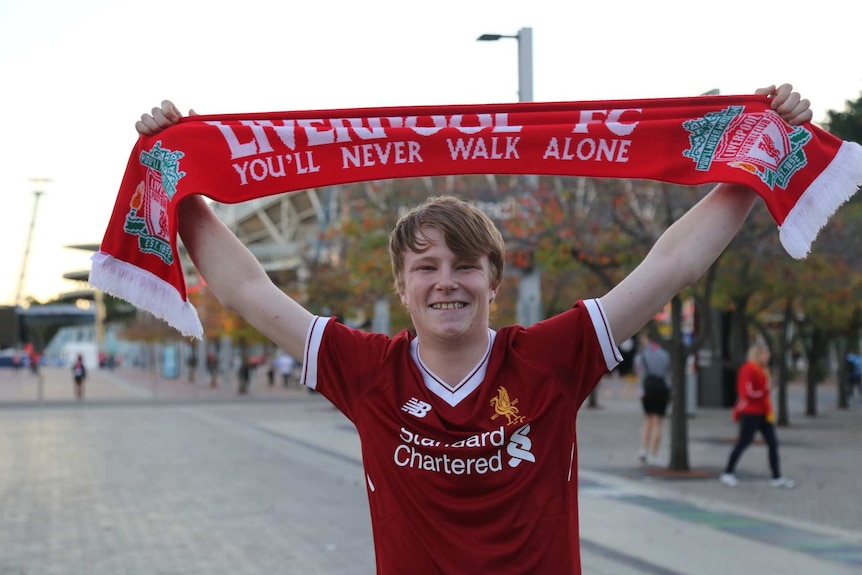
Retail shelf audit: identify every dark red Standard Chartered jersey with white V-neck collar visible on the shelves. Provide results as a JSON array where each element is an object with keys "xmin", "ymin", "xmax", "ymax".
[{"xmin": 303, "ymin": 300, "xmax": 622, "ymax": 575}]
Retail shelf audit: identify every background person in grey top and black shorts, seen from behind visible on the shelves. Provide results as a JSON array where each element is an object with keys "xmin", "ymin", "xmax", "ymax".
[{"xmin": 635, "ymin": 332, "xmax": 670, "ymax": 464}]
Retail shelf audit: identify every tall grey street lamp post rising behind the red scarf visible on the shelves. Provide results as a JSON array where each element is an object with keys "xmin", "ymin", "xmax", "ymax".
[{"xmin": 477, "ymin": 28, "xmax": 542, "ymax": 326}]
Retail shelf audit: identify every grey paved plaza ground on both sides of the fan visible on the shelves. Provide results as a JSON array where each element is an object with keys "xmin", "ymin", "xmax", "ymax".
[{"xmin": 0, "ymin": 368, "xmax": 862, "ymax": 575}]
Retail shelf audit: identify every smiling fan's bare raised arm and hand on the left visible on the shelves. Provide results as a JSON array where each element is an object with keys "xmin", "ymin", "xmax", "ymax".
[{"xmin": 140, "ymin": 100, "xmax": 312, "ymax": 357}]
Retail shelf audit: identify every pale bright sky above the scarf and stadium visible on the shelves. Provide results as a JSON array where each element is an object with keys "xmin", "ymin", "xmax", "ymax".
[{"xmin": 0, "ymin": 0, "xmax": 862, "ymax": 305}]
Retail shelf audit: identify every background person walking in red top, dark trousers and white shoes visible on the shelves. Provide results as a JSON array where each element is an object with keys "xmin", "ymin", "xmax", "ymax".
[{"xmin": 719, "ymin": 343, "xmax": 796, "ymax": 489}]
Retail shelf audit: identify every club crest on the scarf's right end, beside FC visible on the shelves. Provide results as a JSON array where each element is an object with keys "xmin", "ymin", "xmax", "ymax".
[{"xmin": 683, "ymin": 106, "xmax": 811, "ymax": 189}]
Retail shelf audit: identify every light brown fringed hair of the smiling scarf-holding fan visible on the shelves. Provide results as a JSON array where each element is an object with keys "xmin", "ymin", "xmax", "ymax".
[{"xmin": 389, "ymin": 196, "xmax": 506, "ymax": 291}]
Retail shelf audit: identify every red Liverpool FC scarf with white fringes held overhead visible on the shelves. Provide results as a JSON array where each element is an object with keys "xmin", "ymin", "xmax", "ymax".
[{"xmin": 90, "ymin": 96, "xmax": 862, "ymax": 337}]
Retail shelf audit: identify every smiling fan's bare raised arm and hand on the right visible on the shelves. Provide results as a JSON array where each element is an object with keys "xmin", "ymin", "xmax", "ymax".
[{"xmin": 602, "ymin": 84, "xmax": 812, "ymax": 344}]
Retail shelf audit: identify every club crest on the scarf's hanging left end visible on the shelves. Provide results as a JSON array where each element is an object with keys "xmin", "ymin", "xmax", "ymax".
[{"xmin": 123, "ymin": 141, "xmax": 186, "ymax": 265}]
